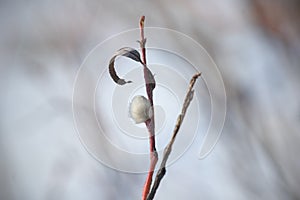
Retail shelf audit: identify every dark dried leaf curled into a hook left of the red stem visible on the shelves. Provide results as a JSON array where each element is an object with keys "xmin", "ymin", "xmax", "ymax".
[{"xmin": 109, "ymin": 47, "xmax": 142, "ymax": 85}]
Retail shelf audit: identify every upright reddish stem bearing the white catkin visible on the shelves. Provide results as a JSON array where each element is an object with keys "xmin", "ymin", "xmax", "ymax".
[{"xmin": 140, "ymin": 16, "xmax": 158, "ymax": 200}]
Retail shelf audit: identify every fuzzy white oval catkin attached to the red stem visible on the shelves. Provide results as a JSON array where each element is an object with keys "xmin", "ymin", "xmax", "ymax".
[{"xmin": 129, "ymin": 95, "xmax": 152, "ymax": 124}]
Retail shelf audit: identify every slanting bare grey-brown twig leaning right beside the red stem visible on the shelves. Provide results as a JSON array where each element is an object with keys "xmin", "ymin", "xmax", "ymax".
[{"xmin": 147, "ymin": 73, "xmax": 201, "ymax": 200}]
